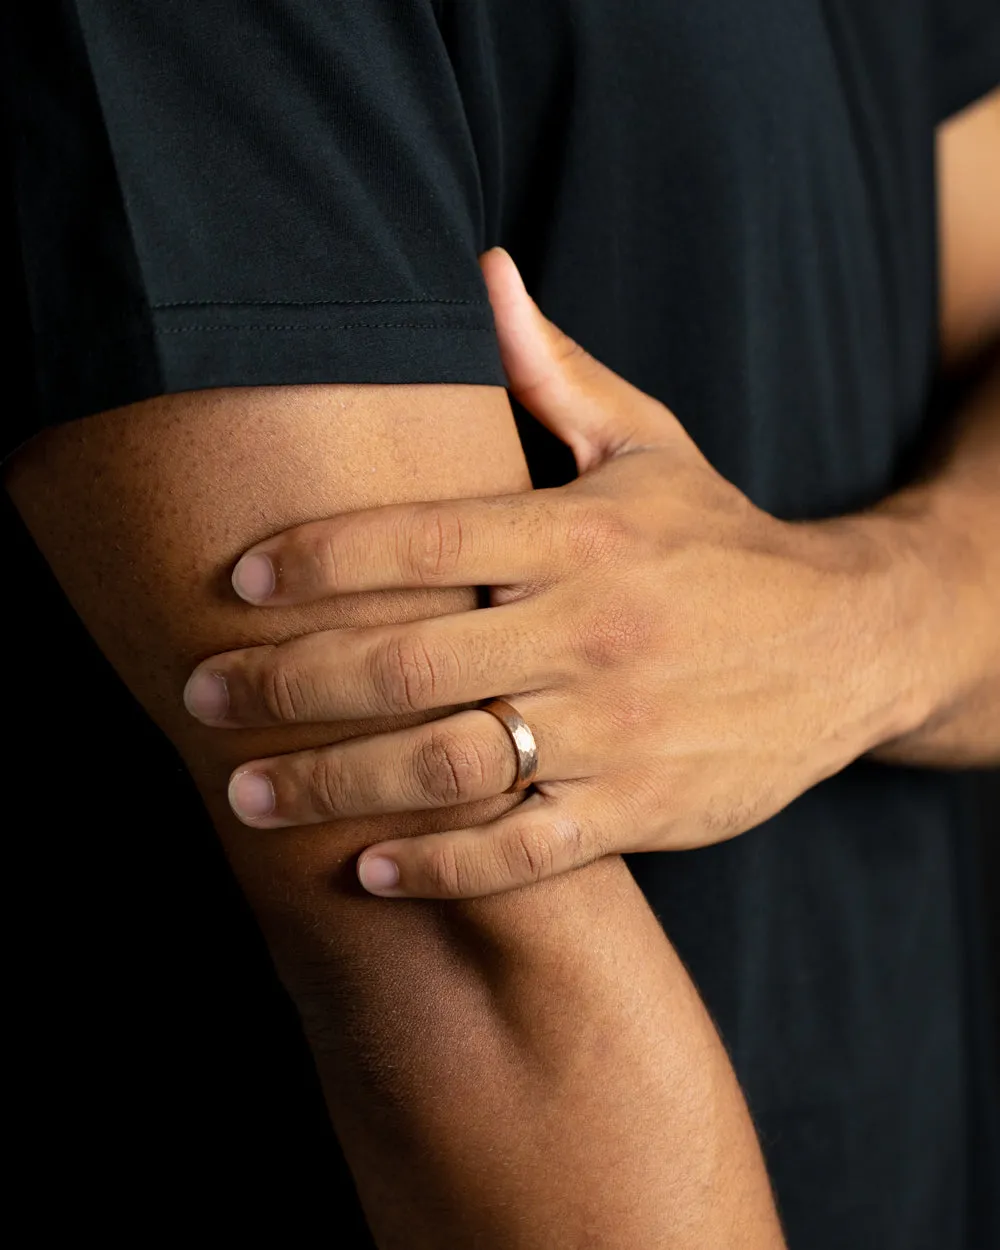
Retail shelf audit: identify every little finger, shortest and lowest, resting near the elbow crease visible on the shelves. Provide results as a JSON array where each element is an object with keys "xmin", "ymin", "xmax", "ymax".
[{"xmin": 358, "ymin": 781, "xmax": 638, "ymax": 899}]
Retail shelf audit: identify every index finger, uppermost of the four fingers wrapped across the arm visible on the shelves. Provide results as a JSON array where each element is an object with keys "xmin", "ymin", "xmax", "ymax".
[{"xmin": 233, "ymin": 491, "xmax": 558, "ymax": 605}]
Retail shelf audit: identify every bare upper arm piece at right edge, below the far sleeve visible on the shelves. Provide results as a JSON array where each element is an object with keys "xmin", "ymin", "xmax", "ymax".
[{"xmin": 938, "ymin": 89, "xmax": 1000, "ymax": 364}]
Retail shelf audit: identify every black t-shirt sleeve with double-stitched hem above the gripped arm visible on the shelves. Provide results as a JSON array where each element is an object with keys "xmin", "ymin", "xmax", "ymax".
[{"xmin": 3, "ymin": 0, "xmax": 504, "ymax": 451}]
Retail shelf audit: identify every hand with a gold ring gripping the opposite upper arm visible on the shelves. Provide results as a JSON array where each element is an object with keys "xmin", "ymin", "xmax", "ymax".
[{"xmin": 185, "ymin": 250, "xmax": 898, "ymax": 898}]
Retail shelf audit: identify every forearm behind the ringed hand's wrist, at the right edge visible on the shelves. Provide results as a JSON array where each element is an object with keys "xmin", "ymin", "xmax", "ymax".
[{"xmin": 851, "ymin": 353, "xmax": 1000, "ymax": 768}]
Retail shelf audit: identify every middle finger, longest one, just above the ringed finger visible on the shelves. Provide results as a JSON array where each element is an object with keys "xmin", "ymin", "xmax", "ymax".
[{"xmin": 184, "ymin": 600, "xmax": 555, "ymax": 728}]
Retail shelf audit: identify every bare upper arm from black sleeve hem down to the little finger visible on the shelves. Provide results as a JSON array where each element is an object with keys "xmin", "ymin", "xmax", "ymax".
[{"xmin": 6, "ymin": 385, "xmax": 530, "ymax": 940}]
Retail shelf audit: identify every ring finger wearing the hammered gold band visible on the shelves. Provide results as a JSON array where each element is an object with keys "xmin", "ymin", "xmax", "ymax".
[{"xmin": 221, "ymin": 698, "xmax": 560, "ymax": 829}]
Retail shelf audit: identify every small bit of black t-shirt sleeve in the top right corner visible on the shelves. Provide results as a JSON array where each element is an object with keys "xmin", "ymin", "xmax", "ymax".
[{"xmin": 933, "ymin": 0, "xmax": 1000, "ymax": 121}]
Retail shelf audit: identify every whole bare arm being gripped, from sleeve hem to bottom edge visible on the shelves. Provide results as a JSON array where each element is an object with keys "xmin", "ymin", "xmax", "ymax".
[{"xmin": 8, "ymin": 386, "xmax": 781, "ymax": 1250}]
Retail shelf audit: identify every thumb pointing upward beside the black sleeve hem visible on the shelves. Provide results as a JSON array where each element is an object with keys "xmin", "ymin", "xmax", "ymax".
[{"xmin": 480, "ymin": 248, "xmax": 675, "ymax": 473}]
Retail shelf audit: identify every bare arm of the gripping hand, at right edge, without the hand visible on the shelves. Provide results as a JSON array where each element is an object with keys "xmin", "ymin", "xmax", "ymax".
[{"xmin": 865, "ymin": 90, "xmax": 1000, "ymax": 766}]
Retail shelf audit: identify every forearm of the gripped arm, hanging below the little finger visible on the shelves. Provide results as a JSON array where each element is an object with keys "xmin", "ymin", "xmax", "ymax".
[{"xmin": 236, "ymin": 810, "xmax": 781, "ymax": 1250}]
